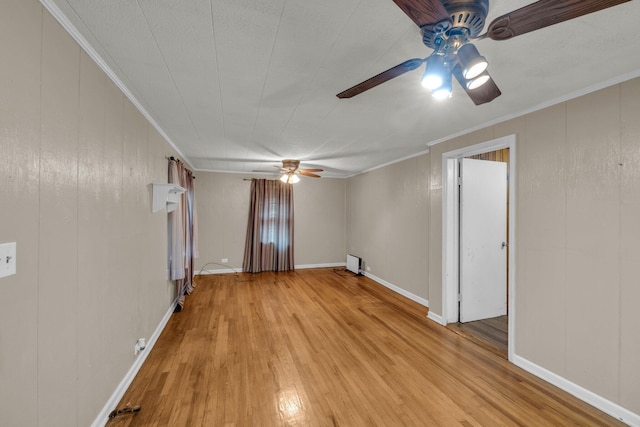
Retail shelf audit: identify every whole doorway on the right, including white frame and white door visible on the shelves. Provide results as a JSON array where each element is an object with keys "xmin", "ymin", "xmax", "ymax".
[{"xmin": 443, "ymin": 136, "xmax": 515, "ymax": 358}]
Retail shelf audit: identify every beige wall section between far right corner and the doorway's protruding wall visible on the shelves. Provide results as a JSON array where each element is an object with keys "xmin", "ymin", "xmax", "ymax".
[{"xmin": 347, "ymin": 154, "xmax": 431, "ymax": 300}]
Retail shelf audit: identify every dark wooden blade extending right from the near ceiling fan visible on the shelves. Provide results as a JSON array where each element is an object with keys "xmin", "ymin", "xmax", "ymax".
[{"xmin": 486, "ymin": 0, "xmax": 630, "ymax": 40}]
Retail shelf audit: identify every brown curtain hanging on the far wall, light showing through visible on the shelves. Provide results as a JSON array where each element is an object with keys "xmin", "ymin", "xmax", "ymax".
[{"xmin": 242, "ymin": 179, "xmax": 294, "ymax": 273}]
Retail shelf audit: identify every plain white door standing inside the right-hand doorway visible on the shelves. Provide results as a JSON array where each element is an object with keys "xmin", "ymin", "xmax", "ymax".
[{"xmin": 460, "ymin": 159, "xmax": 507, "ymax": 322}]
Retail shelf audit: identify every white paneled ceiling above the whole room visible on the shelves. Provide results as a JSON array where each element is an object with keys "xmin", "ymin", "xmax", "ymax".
[{"xmin": 41, "ymin": 0, "xmax": 640, "ymax": 177}]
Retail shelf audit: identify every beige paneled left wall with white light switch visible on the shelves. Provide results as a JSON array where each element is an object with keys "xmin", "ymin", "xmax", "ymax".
[{"xmin": 0, "ymin": 0, "xmax": 174, "ymax": 426}]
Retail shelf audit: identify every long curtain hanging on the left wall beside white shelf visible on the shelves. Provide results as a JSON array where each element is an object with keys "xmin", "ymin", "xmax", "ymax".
[{"xmin": 169, "ymin": 157, "xmax": 199, "ymax": 311}]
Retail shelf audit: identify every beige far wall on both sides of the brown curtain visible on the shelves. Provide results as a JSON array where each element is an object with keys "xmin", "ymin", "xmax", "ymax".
[{"xmin": 195, "ymin": 172, "xmax": 346, "ymax": 272}]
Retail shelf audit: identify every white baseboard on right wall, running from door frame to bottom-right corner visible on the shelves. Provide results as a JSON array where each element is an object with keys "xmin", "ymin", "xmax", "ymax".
[{"xmin": 512, "ymin": 355, "xmax": 640, "ymax": 427}]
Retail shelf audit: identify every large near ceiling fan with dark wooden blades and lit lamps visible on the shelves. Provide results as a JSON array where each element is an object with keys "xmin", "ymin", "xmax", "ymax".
[{"xmin": 336, "ymin": 0, "xmax": 630, "ymax": 105}]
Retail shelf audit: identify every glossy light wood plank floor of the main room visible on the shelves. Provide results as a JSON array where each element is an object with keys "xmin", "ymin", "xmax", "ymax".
[{"xmin": 108, "ymin": 269, "xmax": 622, "ymax": 427}]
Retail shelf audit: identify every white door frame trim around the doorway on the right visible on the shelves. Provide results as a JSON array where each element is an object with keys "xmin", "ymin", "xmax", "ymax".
[{"xmin": 442, "ymin": 135, "xmax": 516, "ymax": 361}]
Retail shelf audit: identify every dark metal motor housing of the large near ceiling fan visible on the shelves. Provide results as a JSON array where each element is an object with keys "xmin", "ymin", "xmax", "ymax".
[{"xmin": 421, "ymin": 0, "xmax": 489, "ymax": 49}]
